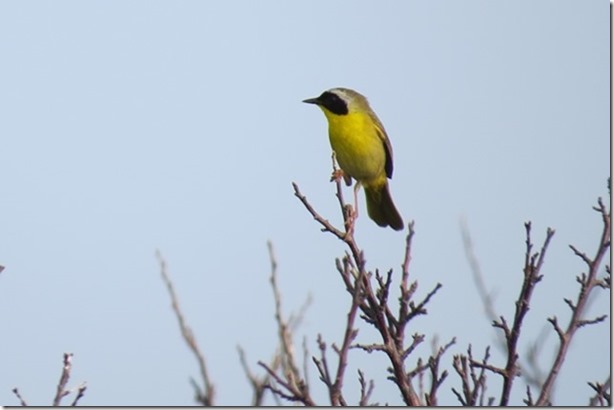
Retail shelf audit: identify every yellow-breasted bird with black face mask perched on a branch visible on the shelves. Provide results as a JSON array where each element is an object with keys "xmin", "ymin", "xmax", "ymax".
[{"xmin": 303, "ymin": 87, "xmax": 403, "ymax": 231}]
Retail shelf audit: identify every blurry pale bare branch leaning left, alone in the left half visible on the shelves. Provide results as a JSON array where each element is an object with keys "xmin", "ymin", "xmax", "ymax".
[{"xmin": 156, "ymin": 250, "xmax": 215, "ymax": 406}]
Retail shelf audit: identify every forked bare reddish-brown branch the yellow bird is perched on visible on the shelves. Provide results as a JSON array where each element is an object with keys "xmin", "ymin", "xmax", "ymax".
[{"xmin": 292, "ymin": 158, "xmax": 448, "ymax": 405}]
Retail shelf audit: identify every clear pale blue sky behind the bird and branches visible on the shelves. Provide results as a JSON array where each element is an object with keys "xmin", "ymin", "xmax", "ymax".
[{"xmin": 0, "ymin": 0, "xmax": 610, "ymax": 405}]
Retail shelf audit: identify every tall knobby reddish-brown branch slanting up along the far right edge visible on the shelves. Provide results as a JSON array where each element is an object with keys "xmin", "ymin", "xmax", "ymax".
[{"xmin": 535, "ymin": 198, "xmax": 611, "ymax": 406}]
